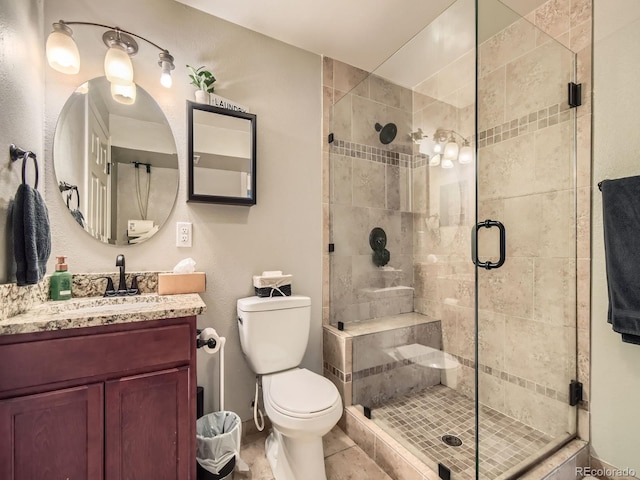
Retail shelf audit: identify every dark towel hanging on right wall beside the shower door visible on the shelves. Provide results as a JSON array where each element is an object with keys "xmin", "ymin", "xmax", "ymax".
[{"xmin": 600, "ymin": 176, "xmax": 640, "ymax": 345}]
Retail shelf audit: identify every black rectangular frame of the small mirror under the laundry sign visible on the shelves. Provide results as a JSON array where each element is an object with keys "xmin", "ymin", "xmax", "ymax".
[{"xmin": 187, "ymin": 100, "xmax": 257, "ymax": 206}]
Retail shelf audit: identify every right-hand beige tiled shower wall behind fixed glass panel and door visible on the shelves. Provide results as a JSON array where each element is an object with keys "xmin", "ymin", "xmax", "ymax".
[{"xmin": 414, "ymin": 1, "xmax": 590, "ymax": 435}]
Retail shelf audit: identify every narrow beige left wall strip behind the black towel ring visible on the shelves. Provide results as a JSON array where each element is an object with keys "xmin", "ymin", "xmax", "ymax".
[{"xmin": 0, "ymin": 0, "xmax": 45, "ymax": 283}]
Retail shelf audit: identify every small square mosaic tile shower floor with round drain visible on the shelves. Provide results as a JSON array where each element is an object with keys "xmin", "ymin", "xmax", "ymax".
[{"xmin": 372, "ymin": 385, "xmax": 553, "ymax": 480}]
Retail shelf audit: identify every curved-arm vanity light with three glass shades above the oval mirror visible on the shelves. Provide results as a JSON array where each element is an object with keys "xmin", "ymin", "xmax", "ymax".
[{"xmin": 46, "ymin": 20, "xmax": 175, "ymax": 93}]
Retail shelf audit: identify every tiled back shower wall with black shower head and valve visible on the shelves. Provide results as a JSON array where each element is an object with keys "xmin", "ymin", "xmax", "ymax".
[{"xmin": 325, "ymin": 59, "xmax": 413, "ymax": 325}]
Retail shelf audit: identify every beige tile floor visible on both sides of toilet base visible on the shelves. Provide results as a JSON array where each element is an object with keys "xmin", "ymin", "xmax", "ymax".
[{"xmin": 238, "ymin": 426, "xmax": 392, "ymax": 480}]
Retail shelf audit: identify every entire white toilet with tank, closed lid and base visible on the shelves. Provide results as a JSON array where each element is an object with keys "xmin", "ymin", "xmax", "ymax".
[{"xmin": 237, "ymin": 295, "xmax": 342, "ymax": 480}]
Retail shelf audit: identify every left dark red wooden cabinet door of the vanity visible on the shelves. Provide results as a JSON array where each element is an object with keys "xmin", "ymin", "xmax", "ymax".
[{"xmin": 0, "ymin": 384, "xmax": 104, "ymax": 480}]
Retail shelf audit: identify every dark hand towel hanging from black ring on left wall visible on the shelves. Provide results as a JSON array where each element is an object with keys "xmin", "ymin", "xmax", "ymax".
[{"xmin": 12, "ymin": 184, "xmax": 51, "ymax": 286}]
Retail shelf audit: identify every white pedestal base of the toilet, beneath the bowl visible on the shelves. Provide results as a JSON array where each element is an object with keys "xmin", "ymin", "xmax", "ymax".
[{"xmin": 265, "ymin": 427, "xmax": 327, "ymax": 480}]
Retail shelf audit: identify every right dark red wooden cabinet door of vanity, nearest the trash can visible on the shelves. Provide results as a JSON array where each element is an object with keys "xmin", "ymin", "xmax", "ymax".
[{"xmin": 105, "ymin": 367, "xmax": 189, "ymax": 480}]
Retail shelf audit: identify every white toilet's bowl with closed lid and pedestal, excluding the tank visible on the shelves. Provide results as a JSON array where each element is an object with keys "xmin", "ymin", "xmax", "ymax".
[{"xmin": 262, "ymin": 368, "xmax": 342, "ymax": 480}]
